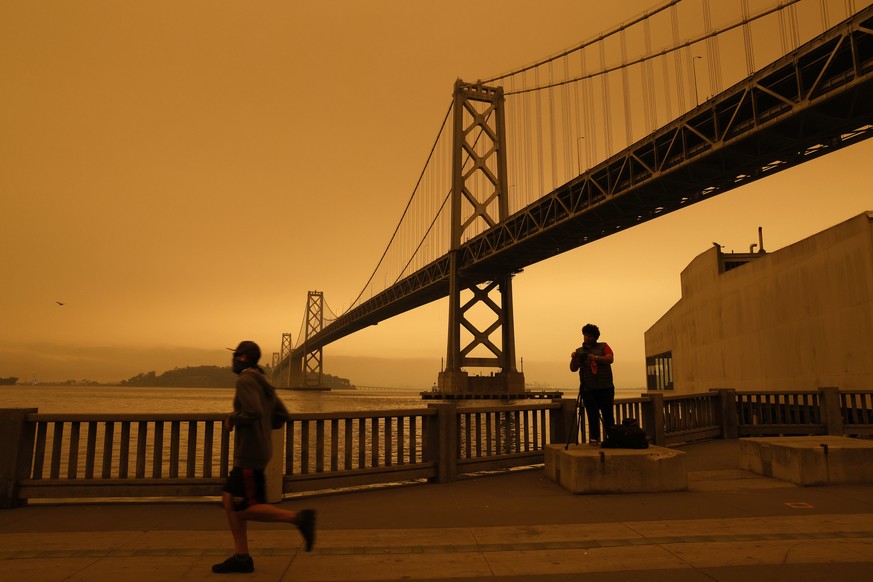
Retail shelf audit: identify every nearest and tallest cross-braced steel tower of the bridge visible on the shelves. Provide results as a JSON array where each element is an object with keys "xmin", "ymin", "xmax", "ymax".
[{"xmin": 439, "ymin": 79, "xmax": 524, "ymax": 395}]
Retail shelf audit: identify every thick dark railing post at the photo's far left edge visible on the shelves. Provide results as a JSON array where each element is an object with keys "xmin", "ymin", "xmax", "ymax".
[{"xmin": 0, "ymin": 408, "xmax": 38, "ymax": 509}]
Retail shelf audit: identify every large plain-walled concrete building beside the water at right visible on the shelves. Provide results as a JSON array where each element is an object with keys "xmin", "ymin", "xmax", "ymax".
[{"xmin": 645, "ymin": 211, "xmax": 873, "ymax": 393}]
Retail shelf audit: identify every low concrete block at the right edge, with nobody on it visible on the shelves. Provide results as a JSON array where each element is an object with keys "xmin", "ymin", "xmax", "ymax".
[{"xmin": 740, "ymin": 436, "xmax": 873, "ymax": 486}]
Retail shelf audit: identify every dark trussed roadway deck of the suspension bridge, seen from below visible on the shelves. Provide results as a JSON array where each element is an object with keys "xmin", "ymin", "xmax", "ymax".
[{"xmin": 296, "ymin": 7, "xmax": 873, "ymax": 354}]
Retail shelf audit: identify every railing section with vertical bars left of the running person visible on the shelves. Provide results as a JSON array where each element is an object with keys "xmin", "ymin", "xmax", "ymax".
[{"xmin": 19, "ymin": 414, "xmax": 232, "ymax": 498}]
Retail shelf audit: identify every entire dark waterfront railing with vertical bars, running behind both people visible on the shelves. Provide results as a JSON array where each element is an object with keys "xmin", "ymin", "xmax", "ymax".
[{"xmin": 0, "ymin": 388, "xmax": 873, "ymax": 507}]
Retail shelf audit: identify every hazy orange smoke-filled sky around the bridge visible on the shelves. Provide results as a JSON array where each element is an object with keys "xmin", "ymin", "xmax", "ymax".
[{"xmin": 0, "ymin": 0, "xmax": 873, "ymax": 388}]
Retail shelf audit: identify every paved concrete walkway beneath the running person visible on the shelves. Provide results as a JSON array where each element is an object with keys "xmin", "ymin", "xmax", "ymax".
[{"xmin": 0, "ymin": 441, "xmax": 873, "ymax": 582}]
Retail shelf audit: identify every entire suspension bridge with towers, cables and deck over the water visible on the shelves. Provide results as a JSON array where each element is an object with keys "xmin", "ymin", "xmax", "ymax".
[{"xmin": 273, "ymin": 0, "xmax": 873, "ymax": 395}]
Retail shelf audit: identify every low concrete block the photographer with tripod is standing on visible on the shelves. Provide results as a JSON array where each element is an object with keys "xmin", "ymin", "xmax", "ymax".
[{"xmin": 544, "ymin": 444, "xmax": 688, "ymax": 494}]
